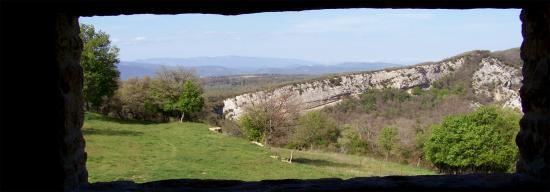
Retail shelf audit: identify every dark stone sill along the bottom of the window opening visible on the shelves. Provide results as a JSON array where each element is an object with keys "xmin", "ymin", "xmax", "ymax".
[{"xmin": 89, "ymin": 174, "xmax": 550, "ymax": 192}]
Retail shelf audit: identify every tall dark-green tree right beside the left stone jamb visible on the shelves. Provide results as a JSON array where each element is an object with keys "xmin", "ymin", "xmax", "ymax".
[{"xmin": 80, "ymin": 24, "xmax": 119, "ymax": 110}]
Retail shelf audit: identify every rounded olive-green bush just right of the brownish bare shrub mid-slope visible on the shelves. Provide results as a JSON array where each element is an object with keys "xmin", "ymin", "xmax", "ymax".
[{"xmin": 290, "ymin": 111, "xmax": 340, "ymax": 149}]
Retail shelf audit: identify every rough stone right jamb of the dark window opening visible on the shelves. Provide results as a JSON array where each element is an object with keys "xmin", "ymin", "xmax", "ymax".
[{"xmin": 516, "ymin": 6, "xmax": 550, "ymax": 180}]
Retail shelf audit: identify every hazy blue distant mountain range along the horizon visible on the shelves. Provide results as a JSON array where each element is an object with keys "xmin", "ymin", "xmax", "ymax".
[{"xmin": 118, "ymin": 56, "xmax": 401, "ymax": 80}]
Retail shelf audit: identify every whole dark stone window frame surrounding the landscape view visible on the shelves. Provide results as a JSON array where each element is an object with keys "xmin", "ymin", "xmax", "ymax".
[{"xmin": 0, "ymin": 0, "xmax": 550, "ymax": 191}]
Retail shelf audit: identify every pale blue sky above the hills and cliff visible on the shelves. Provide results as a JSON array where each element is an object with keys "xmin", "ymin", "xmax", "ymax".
[{"xmin": 80, "ymin": 9, "xmax": 522, "ymax": 64}]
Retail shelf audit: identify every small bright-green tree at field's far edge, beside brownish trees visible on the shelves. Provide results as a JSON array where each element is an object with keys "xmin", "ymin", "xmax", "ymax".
[{"xmin": 174, "ymin": 81, "xmax": 204, "ymax": 122}]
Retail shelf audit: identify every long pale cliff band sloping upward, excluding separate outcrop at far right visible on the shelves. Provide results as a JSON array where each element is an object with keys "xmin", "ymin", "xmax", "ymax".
[{"xmin": 223, "ymin": 58, "xmax": 465, "ymax": 119}]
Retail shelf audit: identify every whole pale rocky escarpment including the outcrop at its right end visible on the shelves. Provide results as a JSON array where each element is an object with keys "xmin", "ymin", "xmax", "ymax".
[{"xmin": 223, "ymin": 51, "xmax": 521, "ymax": 119}]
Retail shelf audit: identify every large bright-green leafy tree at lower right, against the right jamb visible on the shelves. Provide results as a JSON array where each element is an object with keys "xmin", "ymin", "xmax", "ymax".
[{"xmin": 424, "ymin": 106, "xmax": 520, "ymax": 173}]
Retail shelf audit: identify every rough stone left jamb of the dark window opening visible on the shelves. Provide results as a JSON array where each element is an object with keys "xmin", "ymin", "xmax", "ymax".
[{"xmin": 55, "ymin": 14, "xmax": 88, "ymax": 190}]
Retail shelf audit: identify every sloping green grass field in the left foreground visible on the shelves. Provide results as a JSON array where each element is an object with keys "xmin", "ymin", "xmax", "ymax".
[{"xmin": 83, "ymin": 113, "xmax": 434, "ymax": 182}]
